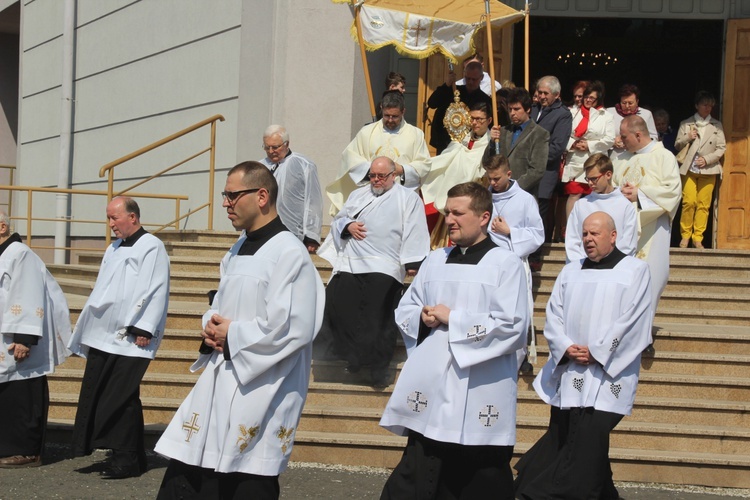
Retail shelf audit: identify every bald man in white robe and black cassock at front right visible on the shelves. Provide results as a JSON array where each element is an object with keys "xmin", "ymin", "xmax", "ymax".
[{"xmin": 515, "ymin": 212, "xmax": 652, "ymax": 499}]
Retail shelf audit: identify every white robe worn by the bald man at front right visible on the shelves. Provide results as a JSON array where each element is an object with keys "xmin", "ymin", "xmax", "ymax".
[{"xmin": 534, "ymin": 256, "xmax": 652, "ymax": 415}]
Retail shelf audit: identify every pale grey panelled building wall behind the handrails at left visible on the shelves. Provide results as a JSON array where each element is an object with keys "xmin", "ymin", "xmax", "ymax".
[{"xmin": 17, "ymin": 0, "xmax": 242, "ymax": 235}]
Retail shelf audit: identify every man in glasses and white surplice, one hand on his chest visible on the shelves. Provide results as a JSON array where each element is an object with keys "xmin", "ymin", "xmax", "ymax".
[{"xmin": 318, "ymin": 157, "xmax": 430, "ymax": 388}]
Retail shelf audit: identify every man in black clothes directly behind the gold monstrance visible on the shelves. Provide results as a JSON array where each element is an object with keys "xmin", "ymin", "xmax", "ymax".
[{"xmin": 427, "ymin": 61, "xmax": 492, "ymax": 154}]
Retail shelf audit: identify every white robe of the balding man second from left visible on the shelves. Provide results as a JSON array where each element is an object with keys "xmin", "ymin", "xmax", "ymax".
[{"xmin": 68, "ymin": 233, "xmax": 169, "ymax": 359}]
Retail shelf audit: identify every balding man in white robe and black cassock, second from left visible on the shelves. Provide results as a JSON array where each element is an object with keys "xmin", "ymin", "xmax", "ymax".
[{"xmin": 68, "ymin": 196, "xmax": 169, "ymax": 479}]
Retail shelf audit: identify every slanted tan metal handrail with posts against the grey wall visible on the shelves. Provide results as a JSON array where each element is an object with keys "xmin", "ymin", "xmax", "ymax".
[{"xmin": 99, "ymin": 115, "xmax": 224, "ymax": 245}]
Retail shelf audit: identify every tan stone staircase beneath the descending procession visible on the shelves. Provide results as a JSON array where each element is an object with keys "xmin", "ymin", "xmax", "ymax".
[{"xmin": 49, "ymin": 231, "xmax": 750, "ymax": 488}]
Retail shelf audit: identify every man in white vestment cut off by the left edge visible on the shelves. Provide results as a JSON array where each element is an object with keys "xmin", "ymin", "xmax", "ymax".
[{"xmin": 0, "ymin": 212, "xmax": 70, "ymax": 468}]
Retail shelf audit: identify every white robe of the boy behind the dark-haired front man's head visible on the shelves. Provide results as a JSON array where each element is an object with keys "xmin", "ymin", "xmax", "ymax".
[{"xmin": 489, "ymin": 181, "xmax": 544, "ymax": 259}]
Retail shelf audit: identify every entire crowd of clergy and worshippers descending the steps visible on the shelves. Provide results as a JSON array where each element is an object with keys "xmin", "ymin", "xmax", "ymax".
[{"xmin": 0, "ymin": 51, "xmax": 726, "ymax": 499}]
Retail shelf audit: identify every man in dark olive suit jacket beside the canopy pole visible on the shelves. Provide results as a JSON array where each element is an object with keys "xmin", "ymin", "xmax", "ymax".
[{"xmin": 484, "ymin": 88, "xmax": 549, "ymax": 195}]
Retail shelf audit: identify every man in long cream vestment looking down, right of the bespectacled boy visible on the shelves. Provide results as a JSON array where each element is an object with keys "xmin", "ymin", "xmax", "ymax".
[{"xmin": 612, "ymin": 116, "xmax": 682, "ymax": 326}]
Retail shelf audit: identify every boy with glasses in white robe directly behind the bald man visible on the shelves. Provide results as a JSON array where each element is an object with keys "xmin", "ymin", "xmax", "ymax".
[{"xmin": 565, "ymin": 153, "xmax": 638, "ymax": 263}]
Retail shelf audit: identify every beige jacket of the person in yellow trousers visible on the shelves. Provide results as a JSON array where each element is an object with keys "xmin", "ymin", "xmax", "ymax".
[{"xmin": 674, "ymin": 115, "xmax": 727, "ymax": 175}]
